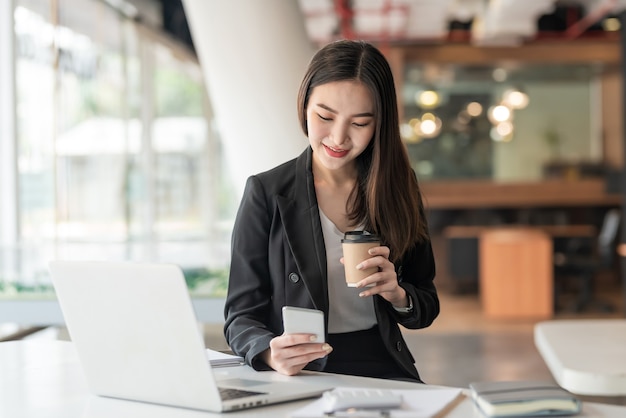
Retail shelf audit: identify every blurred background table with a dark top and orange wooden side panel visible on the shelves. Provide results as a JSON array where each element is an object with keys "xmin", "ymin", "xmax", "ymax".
[{"xmin": 443, "ymin": 224, "xmax": 597, "ymax": 319}]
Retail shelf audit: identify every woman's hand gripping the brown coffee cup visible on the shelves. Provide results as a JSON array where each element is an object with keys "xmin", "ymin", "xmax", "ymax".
[{"xmin": 341, "ymin": 246, "xmax": 409, "ymax": 307}]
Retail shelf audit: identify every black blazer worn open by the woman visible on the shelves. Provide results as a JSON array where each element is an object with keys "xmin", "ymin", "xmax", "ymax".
[{"xmin": 224, "ymin": 147, "xmax": 439, "ymax": 379}]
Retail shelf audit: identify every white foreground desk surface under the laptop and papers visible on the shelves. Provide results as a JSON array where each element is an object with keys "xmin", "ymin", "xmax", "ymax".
[{"xmin": 0, "ymin": 340, "xmax": 626, "ymax": 418}]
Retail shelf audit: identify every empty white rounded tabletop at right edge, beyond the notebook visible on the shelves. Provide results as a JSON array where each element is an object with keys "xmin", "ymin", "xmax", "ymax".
[{"xmin": 535, "ymin": 319, "xmax": 626, "ymax": 396}]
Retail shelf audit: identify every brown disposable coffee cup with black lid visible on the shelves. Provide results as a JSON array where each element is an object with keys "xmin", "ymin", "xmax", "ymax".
[{"xmin": 341, "ymin": 231, "xmax": 380, "ymax": 287}]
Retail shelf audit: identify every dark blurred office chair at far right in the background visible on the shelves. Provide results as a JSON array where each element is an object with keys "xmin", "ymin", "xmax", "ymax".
[{"xmin": 554, "ymin": 209, "xmax": 621, "ymax": 312}]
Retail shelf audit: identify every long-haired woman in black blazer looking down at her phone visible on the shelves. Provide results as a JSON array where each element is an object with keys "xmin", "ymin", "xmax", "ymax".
[{"xmin": 224, "ymin": 41, "xmax": 439, "ymax": 382}]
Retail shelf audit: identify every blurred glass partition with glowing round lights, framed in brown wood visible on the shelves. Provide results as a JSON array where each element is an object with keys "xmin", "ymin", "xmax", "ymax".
[{"xmin": 402, "ymin": 63, "xmax": 607, "ymax": 181}]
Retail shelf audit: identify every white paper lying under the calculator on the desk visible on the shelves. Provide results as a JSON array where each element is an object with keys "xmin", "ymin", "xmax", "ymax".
[{"xmin": 290, "ymin": 386, "xmax": 463, "ymax": 418}]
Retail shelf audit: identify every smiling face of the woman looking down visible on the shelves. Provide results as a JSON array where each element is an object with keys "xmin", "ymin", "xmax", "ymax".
[{"xmin": 306, "ymin": 81, "xmax": 376, "ymax": 176}]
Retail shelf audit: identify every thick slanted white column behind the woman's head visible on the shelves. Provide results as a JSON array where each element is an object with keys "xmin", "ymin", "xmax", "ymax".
[{"xmin": 183, "ymin": 0, "xmax": 315, "ymax": 198}]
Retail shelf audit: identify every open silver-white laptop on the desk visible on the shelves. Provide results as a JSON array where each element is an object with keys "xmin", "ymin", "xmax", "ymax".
[{"xmin": 49, "ymin": 261, "xmax": 331, "ymax": 412}]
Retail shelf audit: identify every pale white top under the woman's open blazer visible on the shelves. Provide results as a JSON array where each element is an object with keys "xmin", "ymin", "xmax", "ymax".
[{"xmin": 320, "ymin": 209, "xmax": 377, "ymax": 334}]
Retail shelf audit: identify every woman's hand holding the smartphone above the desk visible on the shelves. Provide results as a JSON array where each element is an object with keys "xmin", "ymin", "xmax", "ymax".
[{"xmin": 262, "ymin": 334, "xmax": 333, "ymax": 376}]
